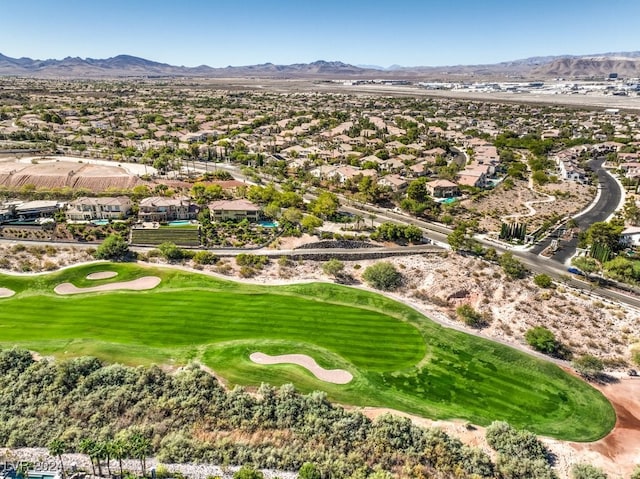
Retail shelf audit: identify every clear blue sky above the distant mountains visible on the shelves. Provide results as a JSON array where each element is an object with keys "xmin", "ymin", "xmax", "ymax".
[{"xmin": 0, "ymin": 0, "xmax": 640, "ymax": 67}]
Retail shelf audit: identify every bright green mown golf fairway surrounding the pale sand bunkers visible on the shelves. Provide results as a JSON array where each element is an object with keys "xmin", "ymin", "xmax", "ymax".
[{"xmin": 0, "ymin": 264, "xmax": 615, "ymax": 441}]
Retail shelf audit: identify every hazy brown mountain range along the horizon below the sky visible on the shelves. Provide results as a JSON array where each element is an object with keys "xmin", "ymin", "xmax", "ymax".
[{"xmin": 0, "ymin": 52, "xmax": 640, "ymax": 80}]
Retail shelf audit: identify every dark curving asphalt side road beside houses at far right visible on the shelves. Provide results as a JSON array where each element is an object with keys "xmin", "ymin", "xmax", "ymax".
[{"xmin": 530, "ymin": 159, "xmax": 622, "ymax": 264}]
